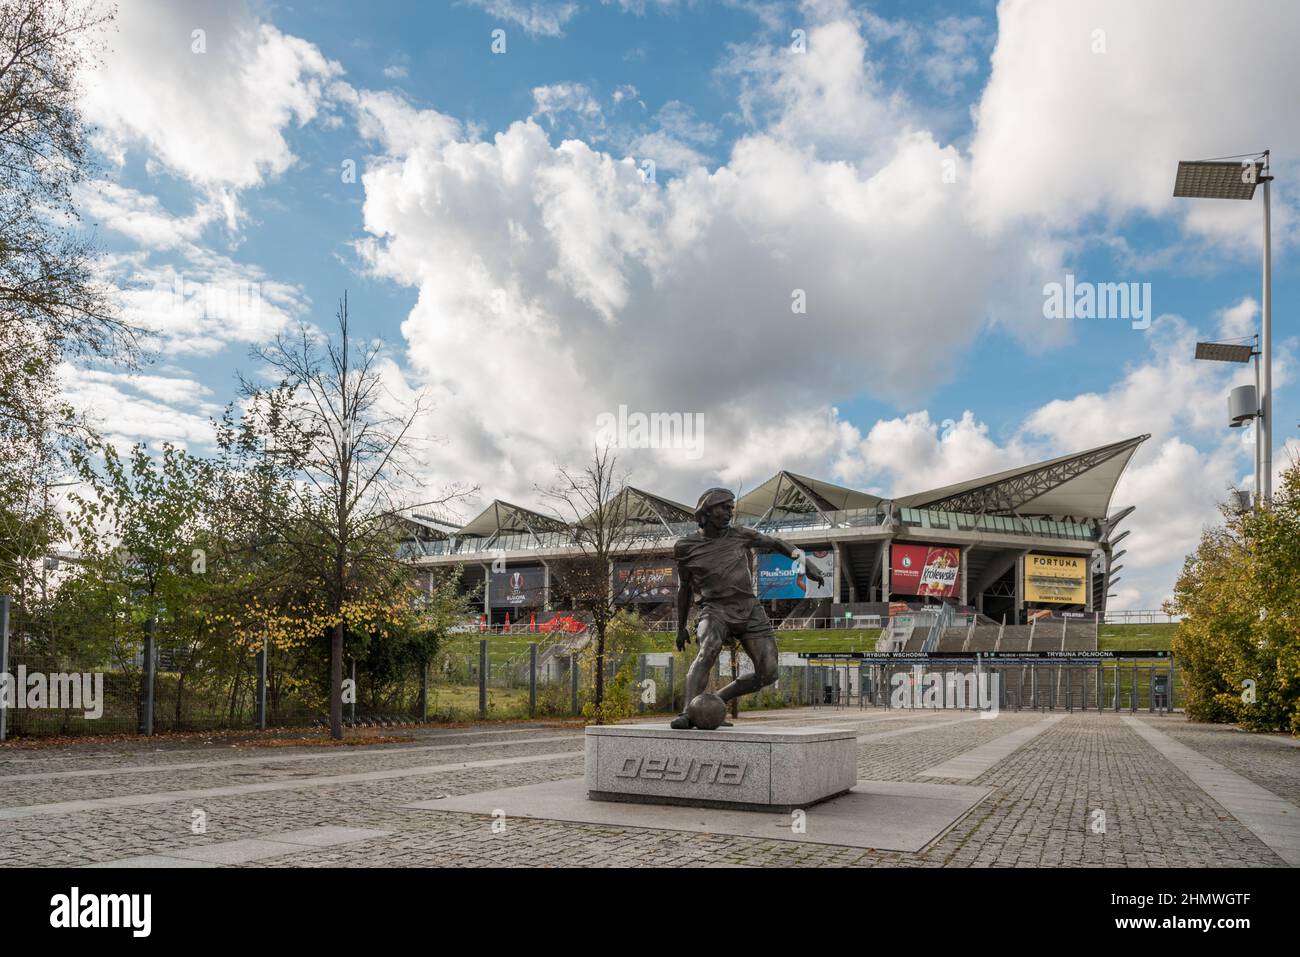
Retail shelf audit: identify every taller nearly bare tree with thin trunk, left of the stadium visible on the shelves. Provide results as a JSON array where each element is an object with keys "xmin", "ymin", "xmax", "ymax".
[{"xmin": 246, "ymin": 295, "xmax": 469, "ymax": 739}]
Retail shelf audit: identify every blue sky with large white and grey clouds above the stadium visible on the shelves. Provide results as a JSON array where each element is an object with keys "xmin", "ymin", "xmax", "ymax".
[{"xmin": 66, "ymin": 0, "xmax": 1300, "ymax": 607}]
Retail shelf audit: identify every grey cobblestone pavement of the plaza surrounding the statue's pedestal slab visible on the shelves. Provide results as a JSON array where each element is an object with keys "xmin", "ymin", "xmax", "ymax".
[{"xmin": 0, "ymin": 709, "xmax": 1300, "ymax": 867}]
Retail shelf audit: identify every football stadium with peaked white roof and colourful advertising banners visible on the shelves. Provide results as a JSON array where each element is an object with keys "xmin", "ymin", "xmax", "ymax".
[{"xmin": 404, "ymin": 436, "xmax": 1148, "ymax": 653}]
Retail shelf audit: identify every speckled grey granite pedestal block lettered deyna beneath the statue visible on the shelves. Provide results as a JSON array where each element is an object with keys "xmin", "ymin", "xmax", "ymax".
[{"xmin": 586, "ymin": 724, "xmax": 858, "ymax": 813}]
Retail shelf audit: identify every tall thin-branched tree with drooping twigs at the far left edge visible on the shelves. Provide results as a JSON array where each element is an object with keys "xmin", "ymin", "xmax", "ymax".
[{"xmin": 0, "ymin": 0, "xmax": 130, "ymax": 622}]
